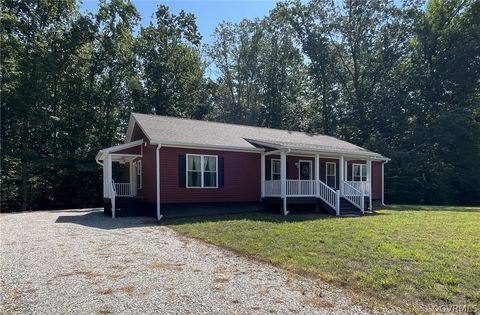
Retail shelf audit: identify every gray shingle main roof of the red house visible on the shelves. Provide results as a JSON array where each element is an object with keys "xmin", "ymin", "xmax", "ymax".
[{"xmin": 127, "ymin": 113, "xmax": 388, "ymax": 158}]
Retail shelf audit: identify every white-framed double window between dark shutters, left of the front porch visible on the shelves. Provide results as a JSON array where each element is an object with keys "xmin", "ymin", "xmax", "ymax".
[{"xmin": 187, "ymin": 154, "xmax": 218, "ymax": 188}]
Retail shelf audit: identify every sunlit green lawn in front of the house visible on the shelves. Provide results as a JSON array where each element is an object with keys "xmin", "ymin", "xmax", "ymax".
[{"xmin": 167, "ymin": 206, "xmax": 480, "ymax": 312}]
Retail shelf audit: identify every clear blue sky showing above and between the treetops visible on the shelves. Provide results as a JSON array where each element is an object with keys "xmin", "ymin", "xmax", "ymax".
[{"xmin": 80, "ymin": 0, "xmax": 277, "ymax": 44}]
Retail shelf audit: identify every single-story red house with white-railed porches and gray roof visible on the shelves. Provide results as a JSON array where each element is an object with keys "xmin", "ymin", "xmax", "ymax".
[{"xmin": 96, "ymin": 113, "xmax": 389, "ymax": 219}]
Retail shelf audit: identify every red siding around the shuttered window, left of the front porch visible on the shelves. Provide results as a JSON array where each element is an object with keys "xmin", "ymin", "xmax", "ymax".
[{"xmin": 159, "ymin": 147, "xmax": 260, "ymax": 203}]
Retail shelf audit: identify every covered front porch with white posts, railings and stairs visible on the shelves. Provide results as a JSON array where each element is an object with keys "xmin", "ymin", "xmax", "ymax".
[{"xmin": 261, "ymin": 149, "xmax": 380, "ymax": 215}]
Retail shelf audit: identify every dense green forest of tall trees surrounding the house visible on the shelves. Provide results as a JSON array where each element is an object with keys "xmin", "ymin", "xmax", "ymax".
[{"xmin": 1, "ymin": 0, "xmax": 480, "ymax": 211}]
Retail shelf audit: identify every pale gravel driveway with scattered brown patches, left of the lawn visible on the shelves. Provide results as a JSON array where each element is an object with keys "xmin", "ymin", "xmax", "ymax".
[{"xmin": 0, "ymin": 209, "xmax": 382, "ymax": 314}]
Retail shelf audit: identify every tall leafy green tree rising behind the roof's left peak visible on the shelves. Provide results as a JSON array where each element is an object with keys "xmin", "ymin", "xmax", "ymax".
[{"xmin": 136, "ymin": 5, "xmax": 207, "ymax": 118}]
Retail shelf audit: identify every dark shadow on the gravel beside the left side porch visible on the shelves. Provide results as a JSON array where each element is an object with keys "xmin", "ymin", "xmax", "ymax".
[{"xmin": 55, "ymin": 211, "xmax": 158, "ymax": 230}]
